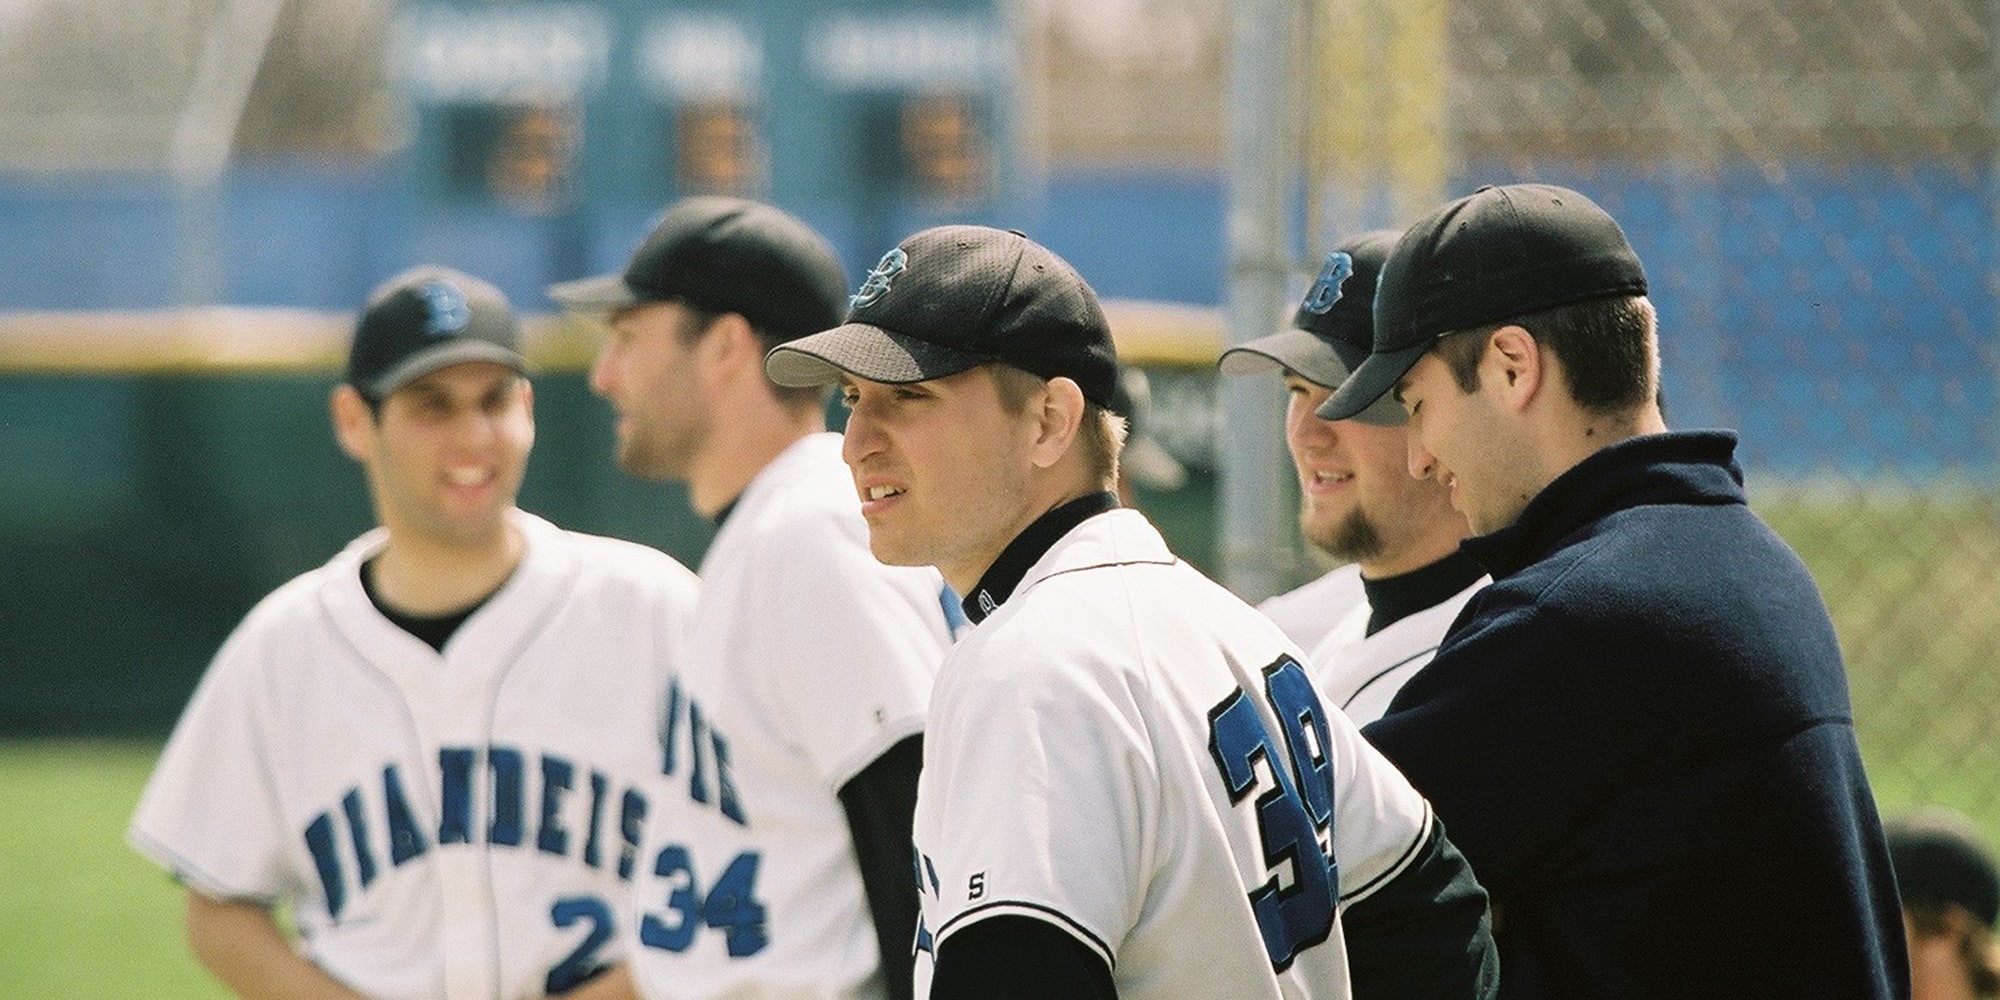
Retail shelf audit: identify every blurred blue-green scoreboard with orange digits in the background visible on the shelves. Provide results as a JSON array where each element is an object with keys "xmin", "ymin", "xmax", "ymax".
[{"xmin": 392, "ymin": 0, "xmax": 1014, "ymax": 214}]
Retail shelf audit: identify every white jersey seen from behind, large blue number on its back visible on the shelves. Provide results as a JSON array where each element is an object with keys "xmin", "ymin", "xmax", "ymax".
[{"xmin": 916, "ymin": 510, "xmax": 1430, "ymax": 1000}]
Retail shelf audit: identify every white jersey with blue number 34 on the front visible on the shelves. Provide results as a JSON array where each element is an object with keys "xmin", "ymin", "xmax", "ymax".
[{"xmin": 634, "ymin": 434, "xmax": 962, "ymax": 1000}]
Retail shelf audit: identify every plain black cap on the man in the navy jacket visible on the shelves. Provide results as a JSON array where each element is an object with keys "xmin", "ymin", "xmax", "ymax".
[{"xmin": 1320, "ymin": 184, "xmax": 1646, "ymax": 420}]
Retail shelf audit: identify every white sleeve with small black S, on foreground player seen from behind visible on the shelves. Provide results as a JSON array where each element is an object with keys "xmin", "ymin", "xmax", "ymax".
[{"xmin": 918, "ymin": 650, "xmax": 1160, "ymax": 966}]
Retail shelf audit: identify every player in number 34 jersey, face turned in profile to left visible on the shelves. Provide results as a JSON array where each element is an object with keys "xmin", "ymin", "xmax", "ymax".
[{"xmin": 552, "ymin": 198, "xmax": 958, "ymax": 1000}]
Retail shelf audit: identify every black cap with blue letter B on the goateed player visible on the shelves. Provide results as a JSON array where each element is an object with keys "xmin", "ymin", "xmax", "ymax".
[{"xmin": 1216, "ymin": 230, "xmax": 1406, "ymax": 426}]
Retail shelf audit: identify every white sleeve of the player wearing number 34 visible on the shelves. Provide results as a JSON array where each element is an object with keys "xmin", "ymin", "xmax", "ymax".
[{"xmin": 762, "ymin": 518, "xmax": 948, "ymax": 792}]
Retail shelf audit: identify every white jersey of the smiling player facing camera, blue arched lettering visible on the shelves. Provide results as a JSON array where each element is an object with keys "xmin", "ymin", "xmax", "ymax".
[{"xmin": 130, "ymin": 510, "xmax": 696, "ymax": 1000}]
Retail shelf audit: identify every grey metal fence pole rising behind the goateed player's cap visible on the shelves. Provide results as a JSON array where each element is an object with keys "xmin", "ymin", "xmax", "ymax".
[{"xmin": 1216, "ymin": 0, "xmax": 1298, "ymax": 600}]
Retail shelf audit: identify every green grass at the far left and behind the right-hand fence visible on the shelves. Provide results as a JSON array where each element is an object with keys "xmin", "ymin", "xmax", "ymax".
[{"xmin": 0, "ymin": 490, "xmax": 2000, "ymax": 1000}]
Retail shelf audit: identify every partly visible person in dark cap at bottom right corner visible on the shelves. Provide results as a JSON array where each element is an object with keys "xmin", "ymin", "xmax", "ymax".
[{"xmin": 1888, "ymin": 808, "xmax": 2000, "ymax": 1000}]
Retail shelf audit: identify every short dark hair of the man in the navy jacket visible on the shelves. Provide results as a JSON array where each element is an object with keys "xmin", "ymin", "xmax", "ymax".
[{"xmin": 1432, "ymin": 296, "xmax": 1660, "ymax": 414}]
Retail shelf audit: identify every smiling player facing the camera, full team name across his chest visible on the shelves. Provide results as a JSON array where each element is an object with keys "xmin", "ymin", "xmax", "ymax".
[{"xmin": 130, "ymin": 268, "xmax": 696, "ymax": 1000}]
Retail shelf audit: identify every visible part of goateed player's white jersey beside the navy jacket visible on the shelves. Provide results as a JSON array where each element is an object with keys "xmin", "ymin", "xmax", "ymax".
[{"xmin": 1312, "ymin": 576, "xmax": 1492, "ymax": 726}]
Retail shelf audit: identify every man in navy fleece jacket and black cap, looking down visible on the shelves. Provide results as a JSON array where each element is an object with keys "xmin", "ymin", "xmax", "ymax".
[{"xmin": 1320, "ymin": 184, "xmax": 1910, "ymax": 1000}]
